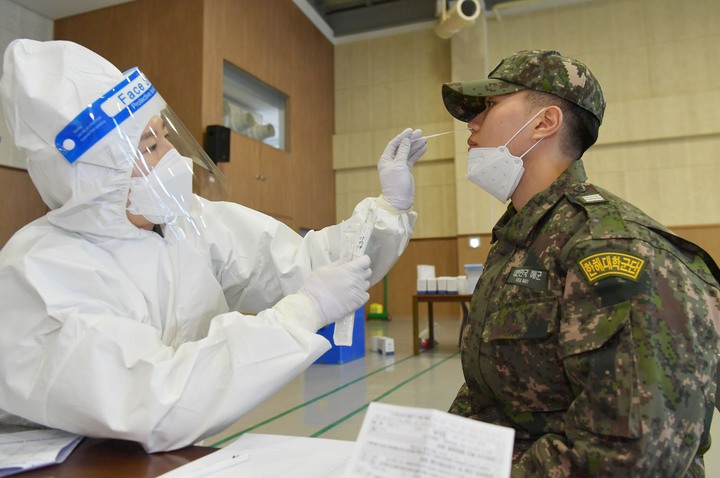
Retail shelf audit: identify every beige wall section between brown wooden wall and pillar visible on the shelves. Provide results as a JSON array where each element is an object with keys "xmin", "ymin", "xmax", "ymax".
[{"xmin": 333, "ymin": 28, "xmax": 457, "ymax": 238}]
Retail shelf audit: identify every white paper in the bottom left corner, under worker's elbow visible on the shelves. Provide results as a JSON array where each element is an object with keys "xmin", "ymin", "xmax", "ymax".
[{"xmin": 0, "ymin": 429, "xmax": 83, "ymax": 477}]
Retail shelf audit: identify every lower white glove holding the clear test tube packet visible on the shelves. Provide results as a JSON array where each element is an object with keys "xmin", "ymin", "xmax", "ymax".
[{"xmin": 298, "ymin": 255, "xmax": 372, "ymax": 327}]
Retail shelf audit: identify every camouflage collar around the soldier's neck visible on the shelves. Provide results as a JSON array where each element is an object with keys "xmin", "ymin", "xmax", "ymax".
[{"xmin": 492, "ymin": 160, "xmax": 587, "ymax": 245}]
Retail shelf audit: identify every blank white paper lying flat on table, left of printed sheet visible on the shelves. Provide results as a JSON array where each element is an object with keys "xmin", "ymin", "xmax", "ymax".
[{"xmin": 159, "ymin": 433, "xmax": 355, "ymax": 478}]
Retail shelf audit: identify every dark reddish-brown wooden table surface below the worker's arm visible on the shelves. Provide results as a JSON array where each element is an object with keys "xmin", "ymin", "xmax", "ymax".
[{"xmin": 18, "ymin": 438, "xmax": 218, "ymax": 478}]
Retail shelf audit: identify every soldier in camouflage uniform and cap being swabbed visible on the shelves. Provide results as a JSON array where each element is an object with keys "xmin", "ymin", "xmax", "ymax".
[{"xmin": 442, "ymin": 50, "xmax": 720, "ymax": 478}]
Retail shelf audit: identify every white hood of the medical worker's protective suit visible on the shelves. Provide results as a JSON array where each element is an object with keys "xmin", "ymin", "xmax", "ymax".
[{"xmin": 0, "ymin": 39, "xmax": 166, "ymax": 238}]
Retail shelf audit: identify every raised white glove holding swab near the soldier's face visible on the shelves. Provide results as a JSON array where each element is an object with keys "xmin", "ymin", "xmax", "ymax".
[{"xmin": 378, "ymin": 128, "xmax": 427, "ymax": 211}]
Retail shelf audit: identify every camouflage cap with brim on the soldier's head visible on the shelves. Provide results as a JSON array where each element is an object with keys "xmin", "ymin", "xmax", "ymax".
[{"xmin": 442, "ymin": 50, "xmax": 605, "ymax": 124}]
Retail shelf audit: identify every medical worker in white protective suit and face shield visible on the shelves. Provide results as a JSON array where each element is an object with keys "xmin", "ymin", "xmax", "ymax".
[{"xmin": 0, "ymin": 40, "xmax": 425, "ymax": 452}]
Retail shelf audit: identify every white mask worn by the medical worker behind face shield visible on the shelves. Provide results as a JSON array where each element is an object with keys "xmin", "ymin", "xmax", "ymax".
[{"xmin": 127, "ymin": 149, "xmax": 193, "ymax": 224}]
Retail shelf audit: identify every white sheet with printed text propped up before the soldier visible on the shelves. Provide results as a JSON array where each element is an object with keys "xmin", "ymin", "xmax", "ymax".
[{"xmin": 344, "ymin": 402, "xmax": 515, "ymax": 478}]
